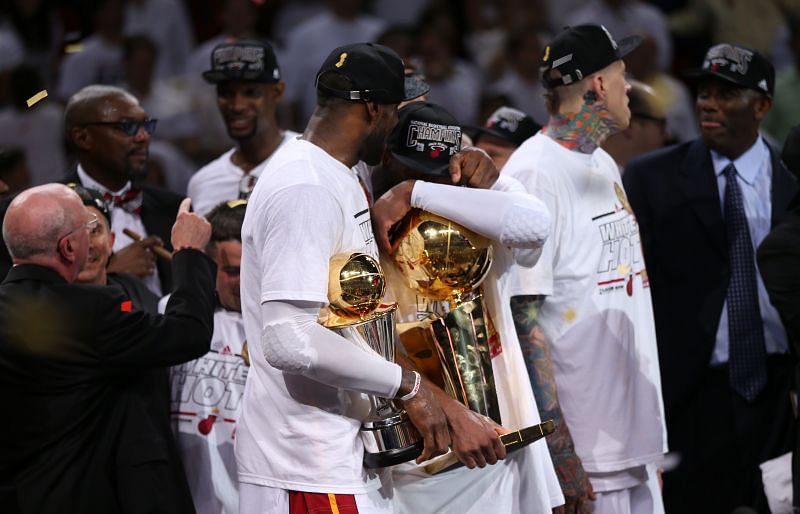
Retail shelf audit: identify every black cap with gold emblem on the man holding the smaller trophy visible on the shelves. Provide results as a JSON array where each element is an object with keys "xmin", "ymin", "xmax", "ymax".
[{"xmin": 316, "ymin": 43, "xmax": 425, "ymax": 104}]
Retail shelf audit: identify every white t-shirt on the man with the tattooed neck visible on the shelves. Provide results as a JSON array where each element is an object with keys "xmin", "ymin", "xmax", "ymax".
[{"xmin": 503, "ymin": 133, "xmax": 667, "ymax": 473}]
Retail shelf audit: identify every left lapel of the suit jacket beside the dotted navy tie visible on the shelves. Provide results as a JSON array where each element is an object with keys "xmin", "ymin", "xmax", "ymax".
[{"xmin": 676, "ymin": 139, "xmax": 728, "ymax": 256}]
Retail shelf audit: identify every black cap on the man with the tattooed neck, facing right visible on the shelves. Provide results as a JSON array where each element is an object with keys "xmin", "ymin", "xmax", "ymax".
[{"xmin": 540, "ymin": 25, "xmax": 642, "ymax": 89}]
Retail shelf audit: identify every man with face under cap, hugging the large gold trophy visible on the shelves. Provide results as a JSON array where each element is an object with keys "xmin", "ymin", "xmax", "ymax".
[{"xmin": 372, "ymin": 102, "xmax": 564, "ymax": 514}]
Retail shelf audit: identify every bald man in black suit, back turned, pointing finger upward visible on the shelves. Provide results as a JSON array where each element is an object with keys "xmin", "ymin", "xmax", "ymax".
[{"xmin": 0, "ymin": 184, "xmax": 215, "ymax": 513}]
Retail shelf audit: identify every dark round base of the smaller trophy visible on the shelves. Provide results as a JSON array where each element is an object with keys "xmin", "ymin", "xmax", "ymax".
[{"xmin": 361, "ymin": 411, "xmax": 423, "ymax": 468}]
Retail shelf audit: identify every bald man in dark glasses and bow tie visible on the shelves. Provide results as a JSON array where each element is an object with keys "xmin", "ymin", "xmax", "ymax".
[{"xmin": 58, "ymin": 85, "xmax": 182, "ymax": 296}]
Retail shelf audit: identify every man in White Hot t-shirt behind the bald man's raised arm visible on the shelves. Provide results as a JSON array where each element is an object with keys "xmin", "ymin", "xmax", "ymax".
[{"xmin": 166, "ymin": 200, "xmax": 250, "ymax": 514}]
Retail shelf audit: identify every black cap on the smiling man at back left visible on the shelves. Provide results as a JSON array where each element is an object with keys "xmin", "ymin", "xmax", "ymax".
[{"xmin": 203, "ymin": 41, "xmax": 281, "ymax": 84}]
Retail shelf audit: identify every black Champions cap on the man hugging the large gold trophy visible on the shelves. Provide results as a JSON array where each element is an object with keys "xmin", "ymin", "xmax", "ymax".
[{"xmin": 388, "ymin": 102, "xmax": 461, "ymax": 177}]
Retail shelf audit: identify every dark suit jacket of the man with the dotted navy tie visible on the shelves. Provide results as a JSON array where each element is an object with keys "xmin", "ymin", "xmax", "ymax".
[{"xmin": 623, "ymin": 139, "xmax": 797, "ymax": 412}]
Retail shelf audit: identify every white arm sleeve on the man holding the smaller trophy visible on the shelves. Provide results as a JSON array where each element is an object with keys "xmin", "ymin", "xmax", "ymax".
[{"xmin": 261, "ymin": 301, "xmax": 403, "ymax": 398}]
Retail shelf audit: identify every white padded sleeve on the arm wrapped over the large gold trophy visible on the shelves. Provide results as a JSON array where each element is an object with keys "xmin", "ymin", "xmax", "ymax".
[{"xmin": 411, "ymin": 180, "xmax": 550, "ymax": 248}]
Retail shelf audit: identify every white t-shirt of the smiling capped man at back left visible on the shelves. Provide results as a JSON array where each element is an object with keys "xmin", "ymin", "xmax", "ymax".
[{"xmin": 188, "ymin": 130, "xmax": 297, "ymax": 215}]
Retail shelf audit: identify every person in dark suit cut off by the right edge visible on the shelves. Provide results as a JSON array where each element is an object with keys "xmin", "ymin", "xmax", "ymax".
[{"xmin": 757, "ymin": 125, "xmax": 800, "ymax": 508}]
